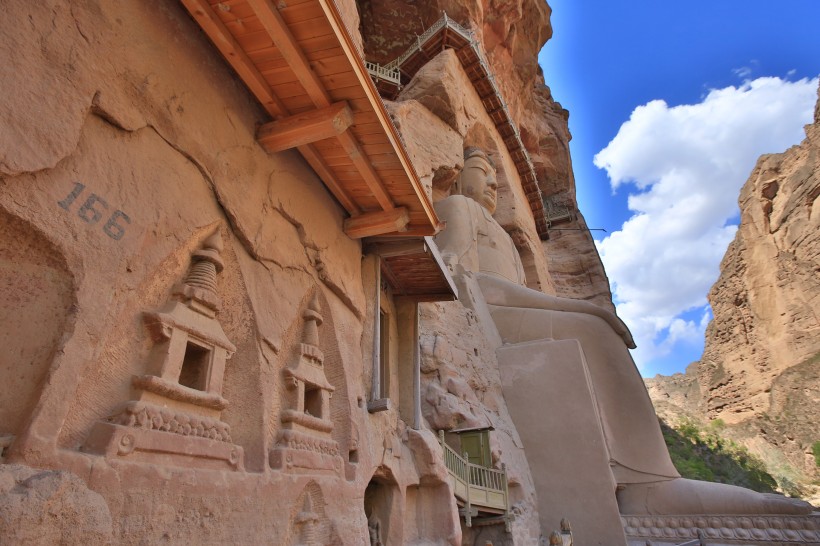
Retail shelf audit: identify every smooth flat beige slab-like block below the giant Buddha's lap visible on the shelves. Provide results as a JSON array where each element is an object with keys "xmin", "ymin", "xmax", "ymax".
[{"xmin": 497, "ymin": 340, "xmax": 626, "ymax": 546}]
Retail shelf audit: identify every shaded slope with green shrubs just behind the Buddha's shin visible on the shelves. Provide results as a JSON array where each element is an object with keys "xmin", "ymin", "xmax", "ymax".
[{"xmin": 659, "ymin": 420, "xmax": 777, "ymax": 493}]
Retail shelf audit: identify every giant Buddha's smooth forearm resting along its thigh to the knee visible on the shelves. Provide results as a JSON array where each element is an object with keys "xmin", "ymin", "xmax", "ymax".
[{"xmin": 480, "ymin": 275, "xmax": 635, "ymax": 349}]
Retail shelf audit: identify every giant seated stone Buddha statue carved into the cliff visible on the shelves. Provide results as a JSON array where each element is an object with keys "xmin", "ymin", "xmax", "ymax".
[{"xmin": 436, "ymin": 148, "xmax": 811, "ymax": 515}]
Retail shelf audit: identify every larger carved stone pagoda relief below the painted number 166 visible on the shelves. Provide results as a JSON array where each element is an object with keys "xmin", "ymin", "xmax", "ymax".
[{"xmin": 84, "ymin": 229, "xmax": 244, "ymax": 470}]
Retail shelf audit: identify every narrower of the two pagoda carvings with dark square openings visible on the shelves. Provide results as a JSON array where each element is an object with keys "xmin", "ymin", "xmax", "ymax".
[{"xmin": 270, "ymin": 292, "xmax": 342, "ymax": 474}]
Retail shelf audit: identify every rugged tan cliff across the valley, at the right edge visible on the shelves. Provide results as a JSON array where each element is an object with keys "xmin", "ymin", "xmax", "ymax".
[{"xmin": 647, "ymin": 86, "xmax": 820, "ymax": 492}]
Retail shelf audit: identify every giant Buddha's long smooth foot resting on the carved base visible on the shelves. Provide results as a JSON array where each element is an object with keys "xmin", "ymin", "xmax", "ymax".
[{"xmin": 618, "ymin": 478, "xmax": 813, "ymax": 515}]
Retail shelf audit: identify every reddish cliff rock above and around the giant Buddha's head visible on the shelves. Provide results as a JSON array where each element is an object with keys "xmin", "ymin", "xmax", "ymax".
[{"xmin": 357, "ymin": 0, "xmax": 614, "ymax": 310}]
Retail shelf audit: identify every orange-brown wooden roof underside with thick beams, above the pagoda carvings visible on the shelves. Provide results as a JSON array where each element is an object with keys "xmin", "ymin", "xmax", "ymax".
[{"xmin": 181, "ymin": 0, "xmax": 441, "ymax": 238}]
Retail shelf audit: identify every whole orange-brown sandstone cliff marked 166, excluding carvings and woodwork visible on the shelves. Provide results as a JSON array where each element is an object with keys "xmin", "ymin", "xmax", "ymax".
[{"xmin": 0, "ymin": 0, "xmax": 608, "ymax": 545}]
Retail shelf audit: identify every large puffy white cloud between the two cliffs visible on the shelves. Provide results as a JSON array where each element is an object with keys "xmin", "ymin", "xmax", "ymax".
[{"xmin": 594, "ymin": 78, "xmax": 818, "ymax": 369}]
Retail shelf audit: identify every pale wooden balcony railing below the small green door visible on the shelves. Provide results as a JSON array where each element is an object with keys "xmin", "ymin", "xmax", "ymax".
[{"xmin": 439, "ymin": 431, "xmax": 509, "ymax": 527}]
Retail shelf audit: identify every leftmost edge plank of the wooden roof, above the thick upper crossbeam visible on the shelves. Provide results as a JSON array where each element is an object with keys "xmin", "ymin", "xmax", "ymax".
[{"xmin": 182, "ymin": 0, "xmax": 288, "ymax": 117}]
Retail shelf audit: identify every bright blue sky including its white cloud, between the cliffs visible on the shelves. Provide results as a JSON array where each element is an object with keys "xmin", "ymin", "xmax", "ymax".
[{"xmin": 539, "ymin": 0, "xmax": 820, "ymax": 376}]
